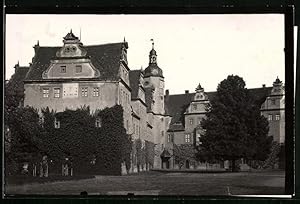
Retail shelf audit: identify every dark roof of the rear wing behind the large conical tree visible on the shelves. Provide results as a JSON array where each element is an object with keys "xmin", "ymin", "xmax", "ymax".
[{"xmin": 165, "ymin": 87, "xmax": 272, "ymax": 130}]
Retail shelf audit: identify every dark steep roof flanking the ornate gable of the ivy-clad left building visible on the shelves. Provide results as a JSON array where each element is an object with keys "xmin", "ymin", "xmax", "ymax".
[{"xmin": 26, "ymin": 42, "xmax": 124, "ymax": 80}]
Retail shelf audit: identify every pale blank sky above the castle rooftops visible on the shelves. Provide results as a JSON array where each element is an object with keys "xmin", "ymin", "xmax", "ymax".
[{"xmin": 5, "ymin": 14, "xmax": 285, "ymax": 94}]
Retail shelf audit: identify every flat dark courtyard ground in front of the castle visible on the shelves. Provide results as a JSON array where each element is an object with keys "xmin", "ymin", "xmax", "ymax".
[{"xmin": 5, "ymin": 171, "xmax": 285, "ymax": 196}]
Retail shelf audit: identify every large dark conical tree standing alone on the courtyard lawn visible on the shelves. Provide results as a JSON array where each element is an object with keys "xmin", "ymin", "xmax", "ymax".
[{"xmin": 198, "ymin": 75, "xmax": 272, "ymax": 171}]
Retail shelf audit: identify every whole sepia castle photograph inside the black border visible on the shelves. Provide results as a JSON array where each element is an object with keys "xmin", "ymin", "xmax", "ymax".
[{"xmin": 3, "ymin": 14, "xmax": 286, "ymax": 196}]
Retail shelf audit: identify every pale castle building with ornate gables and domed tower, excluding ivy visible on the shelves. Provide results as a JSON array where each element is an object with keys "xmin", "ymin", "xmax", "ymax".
[{"xmin": 11, "ymin": 30, "xmax": 285, "ymax": 172}]
